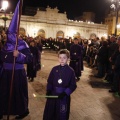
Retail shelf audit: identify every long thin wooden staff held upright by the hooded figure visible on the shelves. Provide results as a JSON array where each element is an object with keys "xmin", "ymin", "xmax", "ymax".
[{"xmin": 7, "ymin": 0, "xmax": 23, "ymax": 120}]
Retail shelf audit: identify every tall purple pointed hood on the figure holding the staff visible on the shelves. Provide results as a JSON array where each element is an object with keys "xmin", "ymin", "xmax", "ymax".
[{"xmin": 3, "ymin": 0, "xmax": 28, "ymax": 51}]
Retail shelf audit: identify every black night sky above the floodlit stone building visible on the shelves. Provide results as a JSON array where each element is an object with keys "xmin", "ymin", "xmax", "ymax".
[{"xmin": 1, "ymin": 0, "xmax": 111, "ymax": 23}]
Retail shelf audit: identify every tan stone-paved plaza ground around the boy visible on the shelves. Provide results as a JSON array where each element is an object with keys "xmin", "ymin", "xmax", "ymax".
[{"xmin": 3, "ymin": 51, "xmax": 120, "ymax": 120}]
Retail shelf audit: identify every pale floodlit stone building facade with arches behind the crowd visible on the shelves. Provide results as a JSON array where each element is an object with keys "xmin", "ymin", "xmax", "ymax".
[{"xmin": 0, "ymin": 6, "xmax": 108, "ymax": 39}]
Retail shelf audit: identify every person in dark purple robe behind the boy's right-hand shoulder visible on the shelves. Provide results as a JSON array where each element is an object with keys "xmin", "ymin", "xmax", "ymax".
[{"xmin": 70, "ymin": 38, "xmax": 82, "ymax": 80}]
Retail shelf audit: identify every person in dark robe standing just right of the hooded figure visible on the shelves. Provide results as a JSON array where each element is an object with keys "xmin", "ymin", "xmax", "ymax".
[{"xmin": 27, "ymin": 41, "xmax": 39, "ymax": 82}]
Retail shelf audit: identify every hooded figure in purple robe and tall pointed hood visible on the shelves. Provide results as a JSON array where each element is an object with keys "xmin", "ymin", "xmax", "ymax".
[{"xmin": 0, "ymin": 1, "xmax": 32, "ymax": 119}]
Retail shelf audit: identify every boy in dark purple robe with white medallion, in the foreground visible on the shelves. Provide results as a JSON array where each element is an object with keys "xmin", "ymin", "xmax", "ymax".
[{"xmin": 43, "ymin": 49, "xmax": 77, "ymax": 120}]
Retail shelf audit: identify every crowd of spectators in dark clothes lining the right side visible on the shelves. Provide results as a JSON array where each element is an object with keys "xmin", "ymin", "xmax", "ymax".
[{"xmin": 84, "ymin": 36, "xmax": 120, "ymax": 97}]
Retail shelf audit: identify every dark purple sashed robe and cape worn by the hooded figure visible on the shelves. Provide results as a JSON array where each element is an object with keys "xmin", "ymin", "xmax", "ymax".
[{"xmin": 0, "ymin": 40, "xmax": 32, "ymax": 115}]
